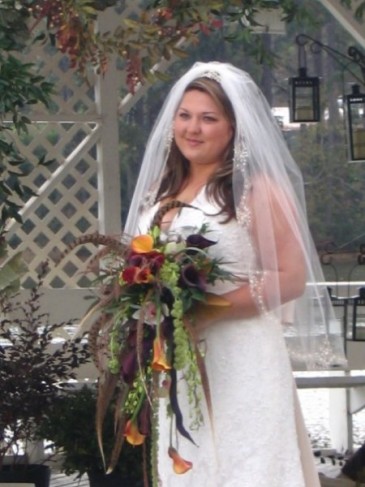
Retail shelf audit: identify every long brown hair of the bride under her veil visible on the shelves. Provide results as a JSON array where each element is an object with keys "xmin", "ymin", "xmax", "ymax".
[{"xmin": 157, "ymin": 78, "xmax": 236, "ymax": 221}]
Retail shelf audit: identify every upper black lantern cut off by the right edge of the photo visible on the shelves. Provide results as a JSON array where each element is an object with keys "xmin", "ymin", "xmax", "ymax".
[{"xmin": 346, "ymin": 85, "xmax": 365, "ymax": 162}]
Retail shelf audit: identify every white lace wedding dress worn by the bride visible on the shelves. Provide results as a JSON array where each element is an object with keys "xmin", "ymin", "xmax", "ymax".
[{"xmin": 139, "ymin": 191, "xmax": 319, "ymax": 487}]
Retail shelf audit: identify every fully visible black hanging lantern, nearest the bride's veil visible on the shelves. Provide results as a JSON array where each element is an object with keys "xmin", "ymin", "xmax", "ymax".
[{"xmin": 289, "ymin": 68, "xmax": 320, "ymax": 123}]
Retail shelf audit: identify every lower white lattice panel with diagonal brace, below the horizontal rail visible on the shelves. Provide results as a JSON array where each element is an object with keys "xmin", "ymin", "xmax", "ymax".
[{"xmin": 9, "ymin": 123, "xmax": 101, "ymax": 287}]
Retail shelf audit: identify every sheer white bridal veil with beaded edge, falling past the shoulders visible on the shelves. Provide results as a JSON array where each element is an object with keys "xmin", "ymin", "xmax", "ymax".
[{"xmin": 125, "ymin": 62, "xmax": 346, "ymax": 368}]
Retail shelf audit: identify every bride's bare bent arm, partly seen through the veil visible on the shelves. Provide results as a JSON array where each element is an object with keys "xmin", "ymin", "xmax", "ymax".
[{"xmin": 194, "ymin": 178, "xmax": 306, "ymax": 328}]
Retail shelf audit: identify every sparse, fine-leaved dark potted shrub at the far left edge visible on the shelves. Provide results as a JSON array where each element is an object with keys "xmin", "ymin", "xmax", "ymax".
[{"xmin": 0, "ymin": 268, "xmax": 90, "ymax": 487}]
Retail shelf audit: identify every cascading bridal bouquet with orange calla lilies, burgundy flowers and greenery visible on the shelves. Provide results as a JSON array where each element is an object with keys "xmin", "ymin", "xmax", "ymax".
[{"xmin": 69, "ymin": 203, "xmax": 234, "ymax": 484}]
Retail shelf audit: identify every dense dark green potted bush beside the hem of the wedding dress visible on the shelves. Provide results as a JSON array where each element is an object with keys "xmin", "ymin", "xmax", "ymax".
[{"xmin": 38, "ymin": 385, "xmax": 143, "ymax": 487}]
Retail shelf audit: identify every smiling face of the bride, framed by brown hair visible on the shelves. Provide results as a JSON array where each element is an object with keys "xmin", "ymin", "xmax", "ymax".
[{"xmin": 174, "ymin": 90, "xmax": 233, "ymax": 171}]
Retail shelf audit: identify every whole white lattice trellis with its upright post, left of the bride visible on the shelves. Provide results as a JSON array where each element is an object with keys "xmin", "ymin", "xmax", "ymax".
[{"xmin": 4, "ymin": 6, "xmax": 125, "ymax": 288}]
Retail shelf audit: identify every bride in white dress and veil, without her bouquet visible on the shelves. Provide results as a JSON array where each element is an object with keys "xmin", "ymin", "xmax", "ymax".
[{"xmin": 126, "ymin": 62, "xmax": 344, "ymax": 487}]
